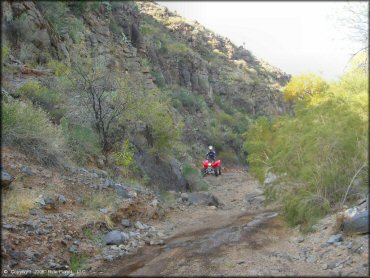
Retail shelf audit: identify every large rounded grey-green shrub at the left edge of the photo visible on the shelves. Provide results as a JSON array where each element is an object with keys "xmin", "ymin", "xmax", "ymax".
[{"xmin": 1, "ymin": 100, "xmax": 64, "ymax": 166}]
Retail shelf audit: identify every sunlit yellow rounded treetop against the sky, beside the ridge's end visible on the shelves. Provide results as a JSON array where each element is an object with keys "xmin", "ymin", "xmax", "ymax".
[{"xmin": 283, "ymin": 73, "xmax": 329, "ymax": 101}]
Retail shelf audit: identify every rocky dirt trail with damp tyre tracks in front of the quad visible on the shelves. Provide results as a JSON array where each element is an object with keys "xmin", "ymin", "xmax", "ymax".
[{"xmin": 100, "ymin": 171, "xmax": 368, "ymax": 276}]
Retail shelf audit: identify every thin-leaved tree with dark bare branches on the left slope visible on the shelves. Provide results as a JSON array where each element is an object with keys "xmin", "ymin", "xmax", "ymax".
[{"xmin": 69, "ymin": 55, "xmax": 135, "ymax": 151}]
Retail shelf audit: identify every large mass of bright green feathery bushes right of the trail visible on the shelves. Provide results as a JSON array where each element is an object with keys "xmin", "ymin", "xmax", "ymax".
[{"xmin": 244, "ymin": 68, "xmax": 368, "ymax": 229}]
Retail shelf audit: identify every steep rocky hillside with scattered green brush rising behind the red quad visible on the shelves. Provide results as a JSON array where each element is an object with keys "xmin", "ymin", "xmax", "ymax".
[{"xmin": 2, "ymin": 2, "xmax": 289, "ymax": 192}]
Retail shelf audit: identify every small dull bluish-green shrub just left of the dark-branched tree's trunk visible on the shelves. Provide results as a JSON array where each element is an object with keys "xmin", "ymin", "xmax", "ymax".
[{"xmin": 61, "ymin": 118, "xmax": 101, "ymax": 165}]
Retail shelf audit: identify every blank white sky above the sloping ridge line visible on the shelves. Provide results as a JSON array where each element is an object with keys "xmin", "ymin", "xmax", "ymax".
[{"xmin": 157, "ymin": 1, "xmax": 368, "ymax": 79}]
